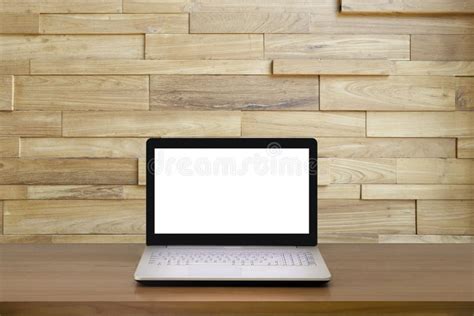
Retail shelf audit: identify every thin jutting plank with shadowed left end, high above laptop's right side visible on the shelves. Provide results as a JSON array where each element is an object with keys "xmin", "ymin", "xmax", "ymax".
[{"xmin": 273, "ymin": 59, "xmax": 393, "ymax": 75}]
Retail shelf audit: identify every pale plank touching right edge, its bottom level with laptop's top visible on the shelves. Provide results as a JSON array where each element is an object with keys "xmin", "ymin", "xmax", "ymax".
[{"xmin": 367, "ymin": 112, "xmax": 474, "ymax": 137}]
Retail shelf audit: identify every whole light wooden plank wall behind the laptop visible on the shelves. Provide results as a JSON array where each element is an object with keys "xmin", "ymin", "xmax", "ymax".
[{"xmin": 0, "ymin": 0, "xmax": 474, "ymax": 243}]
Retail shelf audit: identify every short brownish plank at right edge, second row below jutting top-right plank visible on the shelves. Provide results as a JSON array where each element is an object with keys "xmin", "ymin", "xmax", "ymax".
[{"xmin": 411, "ymin": 34, "xmax": 474, "ymax": 60}]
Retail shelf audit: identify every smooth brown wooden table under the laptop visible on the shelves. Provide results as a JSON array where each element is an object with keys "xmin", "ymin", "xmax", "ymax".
[{"xmin": 0, "ymin": 244, "xmax": 474, "ymax": 316}]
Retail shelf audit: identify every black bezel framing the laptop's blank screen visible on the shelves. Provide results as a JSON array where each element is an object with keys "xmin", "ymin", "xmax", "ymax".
[{"xmin": 146, "ymin": 138, "xmax": 317, "ymax": 246}]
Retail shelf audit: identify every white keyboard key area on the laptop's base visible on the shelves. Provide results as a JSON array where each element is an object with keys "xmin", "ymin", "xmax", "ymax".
[{"xmin": 148, "ymin": 250, "xmax": 316, "ymax": 266}]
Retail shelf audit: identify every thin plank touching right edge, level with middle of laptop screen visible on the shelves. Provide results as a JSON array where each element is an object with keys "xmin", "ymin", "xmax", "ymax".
[{"xmin": 362, "ymin": 184, "xmax": 474, "ymax": 200}]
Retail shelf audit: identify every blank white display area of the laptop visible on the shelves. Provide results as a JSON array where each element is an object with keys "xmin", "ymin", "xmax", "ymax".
[{"xmin": 155, "ymin": 148, "xmax": 309, "ymax": 234}]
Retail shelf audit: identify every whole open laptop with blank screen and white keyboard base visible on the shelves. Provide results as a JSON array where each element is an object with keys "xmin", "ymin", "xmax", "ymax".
[{"xmin": 135, "ymin": 138, "xmax": 331, "ymax": 285}]
